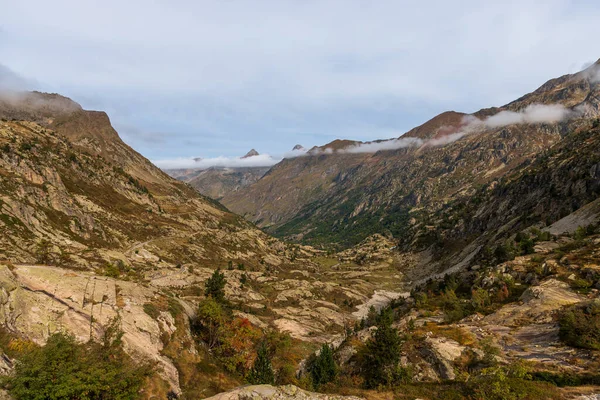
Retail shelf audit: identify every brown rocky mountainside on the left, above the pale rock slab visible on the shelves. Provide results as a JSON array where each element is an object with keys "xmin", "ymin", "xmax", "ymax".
[{"xmin": 0, "ymin": 93, "xmax": 282, "ymax": 267}]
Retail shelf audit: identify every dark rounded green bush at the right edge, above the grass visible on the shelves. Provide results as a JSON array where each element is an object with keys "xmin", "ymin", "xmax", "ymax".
[{"xmin": 558, "ymin": 301, "xmax": 600, "ymax": 350}]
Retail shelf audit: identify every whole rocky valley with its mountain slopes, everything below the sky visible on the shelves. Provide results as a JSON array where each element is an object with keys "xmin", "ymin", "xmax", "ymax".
[{"xmin": 0, "ymin": 62, "xmax": 600, "ymax": 400}]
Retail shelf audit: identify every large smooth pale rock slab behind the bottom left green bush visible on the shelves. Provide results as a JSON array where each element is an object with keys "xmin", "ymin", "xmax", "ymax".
[{"xmin": 0, "ymin": 266, "xmax": 186, "ymax": 391}]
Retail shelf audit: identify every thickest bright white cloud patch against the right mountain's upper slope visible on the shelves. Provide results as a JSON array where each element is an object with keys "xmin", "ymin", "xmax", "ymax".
[{"xmin": 484, "ymin": 104, "xmax": 573, "ymax": 128}]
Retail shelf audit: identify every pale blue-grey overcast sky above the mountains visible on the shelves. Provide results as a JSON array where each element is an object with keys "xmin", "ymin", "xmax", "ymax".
[{"xmin": 0, "ymin": 0, "xmax": 600, "ymax": 167}]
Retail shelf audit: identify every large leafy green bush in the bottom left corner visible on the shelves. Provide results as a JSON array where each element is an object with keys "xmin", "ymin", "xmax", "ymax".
[{"xmin": 8, "ymin": 322, "xmax": 150, "ymax": 400}]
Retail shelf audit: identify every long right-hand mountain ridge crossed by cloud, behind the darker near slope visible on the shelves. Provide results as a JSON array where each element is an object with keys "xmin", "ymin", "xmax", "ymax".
[{"xmin": 222, "ymin": 63, "xmax": 600, "ymax": 266}]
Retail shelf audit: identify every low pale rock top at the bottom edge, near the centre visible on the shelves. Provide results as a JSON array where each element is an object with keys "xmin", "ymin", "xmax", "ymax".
[{"xmin": 206, "ymin": 385, "xmax": 361, "ymax": 400}]
